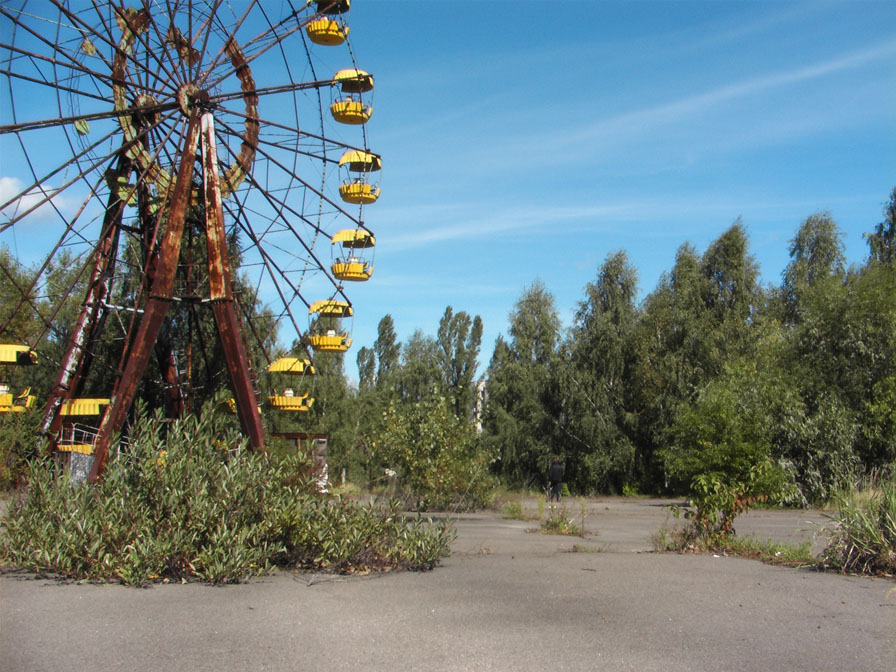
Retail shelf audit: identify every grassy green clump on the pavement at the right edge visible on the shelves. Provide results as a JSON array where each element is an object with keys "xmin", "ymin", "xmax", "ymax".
[{"xmin": 822, "ymin": 475, "xmax": 896, "ymax": 575}]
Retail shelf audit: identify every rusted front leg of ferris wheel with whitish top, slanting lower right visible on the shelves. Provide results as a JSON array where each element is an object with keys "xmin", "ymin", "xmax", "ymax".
[{"xmin": 202, "ymin": 112, "xmax": 264, "ymax": 450}]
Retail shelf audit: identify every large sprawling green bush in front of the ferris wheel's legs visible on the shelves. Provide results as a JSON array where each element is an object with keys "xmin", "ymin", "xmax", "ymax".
[{"xmin": 0, "ymin": 407, "xmax": 454, "ymax": 585}]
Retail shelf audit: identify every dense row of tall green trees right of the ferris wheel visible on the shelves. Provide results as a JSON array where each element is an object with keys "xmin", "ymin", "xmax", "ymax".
[{"xmin": 483, "ymin": 189, "xmax": 896, "ymax": 503}]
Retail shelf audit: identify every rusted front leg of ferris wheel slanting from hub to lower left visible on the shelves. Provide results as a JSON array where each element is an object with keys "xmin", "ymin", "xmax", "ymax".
[{"xmin": 88, "ymin": 106, "xmax": 200, "ymax": 483}]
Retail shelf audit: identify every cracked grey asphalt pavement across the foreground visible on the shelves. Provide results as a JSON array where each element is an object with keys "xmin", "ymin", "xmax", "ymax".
[{"xmin": 0, "ymin": 498, "xmax": 896, "ymax": 672}]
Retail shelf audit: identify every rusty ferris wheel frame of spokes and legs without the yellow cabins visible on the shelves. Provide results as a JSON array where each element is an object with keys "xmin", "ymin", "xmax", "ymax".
[{"xmin": 0, "ymin": 0, "xmax": 376, "ymax": 481}]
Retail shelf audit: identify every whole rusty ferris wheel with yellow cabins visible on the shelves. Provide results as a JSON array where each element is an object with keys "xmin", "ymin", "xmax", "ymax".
[{"xmin": 0, "ymin": 0, "xmax": 382, "ymax": 480}]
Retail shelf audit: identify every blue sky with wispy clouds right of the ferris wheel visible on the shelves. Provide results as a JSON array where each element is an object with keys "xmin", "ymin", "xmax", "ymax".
[{"xmin": 338, "ymin": 0, "xmax": 896, "ymax": 373}]
